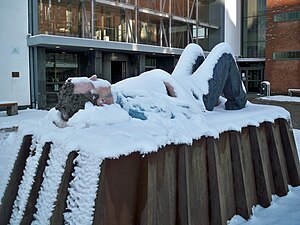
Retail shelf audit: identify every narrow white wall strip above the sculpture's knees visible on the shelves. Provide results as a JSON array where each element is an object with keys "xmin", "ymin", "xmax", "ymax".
[{"xmin": 224, "ymin": 0, "xmax": 242, "ymax": 56}]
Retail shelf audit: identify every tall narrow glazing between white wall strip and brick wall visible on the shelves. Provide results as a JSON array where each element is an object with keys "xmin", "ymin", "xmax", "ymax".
[{"xmin": 242, "ymin": 0, "xmax": 266, "ymax": 58}]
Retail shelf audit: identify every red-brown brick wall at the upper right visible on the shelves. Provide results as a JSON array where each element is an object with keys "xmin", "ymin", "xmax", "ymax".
[{"xmin": 265, "ymin": 0, "xmax": 300, "ymax": 94}]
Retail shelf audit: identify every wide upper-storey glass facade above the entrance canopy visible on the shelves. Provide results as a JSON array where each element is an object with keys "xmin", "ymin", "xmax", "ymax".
[{"xmin": 38, "ymin": 0, "xmax": 221, "ymax": 50}]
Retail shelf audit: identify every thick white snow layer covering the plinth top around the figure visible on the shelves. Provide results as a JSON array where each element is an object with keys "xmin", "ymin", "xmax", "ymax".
[{"xmin": 19, "ymin": 102, "xmax": 290, "ymax": 159}]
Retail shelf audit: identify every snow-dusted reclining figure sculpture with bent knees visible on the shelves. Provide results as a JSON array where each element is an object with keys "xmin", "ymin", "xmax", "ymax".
[{"xmin": 55, "ymin": 43, "xmax": 246, "ymax": 121}]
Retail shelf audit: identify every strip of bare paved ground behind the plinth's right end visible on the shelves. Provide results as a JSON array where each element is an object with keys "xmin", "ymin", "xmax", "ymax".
[{"xmin": 248, "ymin": 97, "xmax": 300, "ymax": 129}]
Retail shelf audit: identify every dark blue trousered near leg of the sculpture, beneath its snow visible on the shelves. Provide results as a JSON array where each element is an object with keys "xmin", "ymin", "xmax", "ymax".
[{"xmin": 203, "ymin": 53, "xmax": 247, "ymax": 111}]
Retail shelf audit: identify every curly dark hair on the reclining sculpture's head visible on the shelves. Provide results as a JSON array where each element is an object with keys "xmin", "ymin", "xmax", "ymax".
[{"xmin": 55, "ymin": 81, "xmax": 97, "ymax": 121}]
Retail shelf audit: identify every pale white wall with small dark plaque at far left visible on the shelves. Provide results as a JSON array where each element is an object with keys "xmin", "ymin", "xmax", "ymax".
[{"xmin": 0, "ymin": 0, "xmax": 30, "ymax": 105}]
